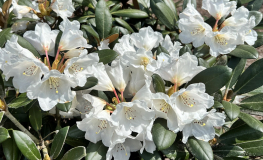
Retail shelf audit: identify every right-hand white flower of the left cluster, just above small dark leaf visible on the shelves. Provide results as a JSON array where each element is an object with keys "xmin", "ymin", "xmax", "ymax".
[{"xmin": 64, "ymin": 53, "xmax": 99, "ymax": 87}]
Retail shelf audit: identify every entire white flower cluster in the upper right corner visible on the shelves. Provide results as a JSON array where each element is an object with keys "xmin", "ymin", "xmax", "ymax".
[{"xmin": 178, "ymin": 0, "xmax": 257, "ymax": 57}]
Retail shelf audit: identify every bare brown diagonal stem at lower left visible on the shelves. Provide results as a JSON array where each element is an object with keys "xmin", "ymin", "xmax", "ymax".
[{"xmin": 5, "ymin": 107, "xmax": 39, "ymax": 144}]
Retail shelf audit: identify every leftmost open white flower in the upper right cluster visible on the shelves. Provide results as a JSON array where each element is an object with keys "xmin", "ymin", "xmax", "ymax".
[{"xmin": 178, "ymin": 17, "xmax": 212, "ymax": 47}]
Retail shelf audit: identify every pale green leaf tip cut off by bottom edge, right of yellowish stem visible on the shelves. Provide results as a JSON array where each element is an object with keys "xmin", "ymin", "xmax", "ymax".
[{"xmin": 61, "ymin": 146, "xmax": 86, "ymax": 160}]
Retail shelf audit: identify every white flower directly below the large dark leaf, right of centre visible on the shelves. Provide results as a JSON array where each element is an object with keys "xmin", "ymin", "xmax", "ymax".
[{"xmin": 173, "ymin": 83, "xmax": 214, "ymax": 128}]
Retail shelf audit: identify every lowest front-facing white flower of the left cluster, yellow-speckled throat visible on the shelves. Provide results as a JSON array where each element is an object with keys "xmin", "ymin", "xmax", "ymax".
[{"xmin": 27, "ymin": 70, "xmax": 77, "ymax": 111}]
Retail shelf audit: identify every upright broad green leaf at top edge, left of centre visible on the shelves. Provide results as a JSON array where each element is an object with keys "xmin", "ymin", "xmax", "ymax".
[{"xmin": 95, "ymin": 0, "xmax": 112, "ymax": 39}]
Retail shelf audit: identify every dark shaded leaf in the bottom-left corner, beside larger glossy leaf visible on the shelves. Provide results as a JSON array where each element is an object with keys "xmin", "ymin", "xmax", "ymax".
[{"xmin": 2, "ymin": 131, "xmax": 21, "ymax": 160}]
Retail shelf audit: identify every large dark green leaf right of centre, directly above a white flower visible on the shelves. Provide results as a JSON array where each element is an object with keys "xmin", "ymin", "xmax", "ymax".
[{"xmin": 188, "ymin": 66, "xmax": 231, "ymax": 94}]
